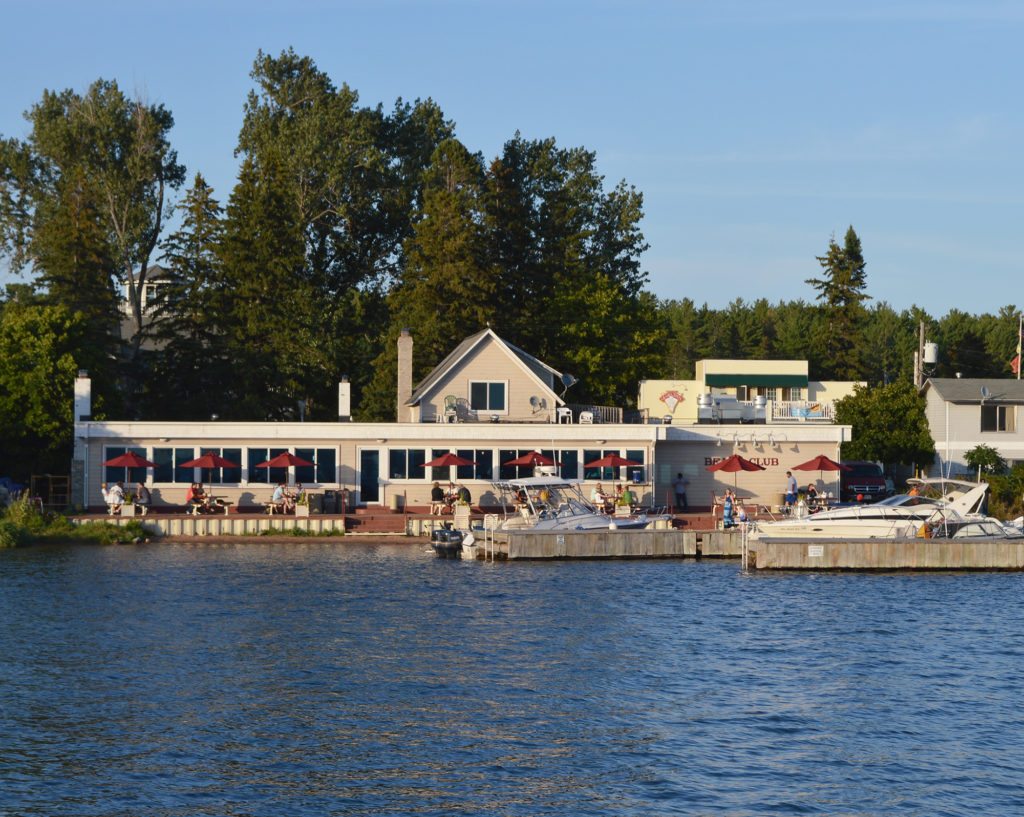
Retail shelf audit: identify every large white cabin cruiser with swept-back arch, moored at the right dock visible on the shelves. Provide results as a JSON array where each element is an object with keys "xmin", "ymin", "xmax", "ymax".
[{"xmin": 748, "ymin": 478, "xmax": 1022, "ymax": 543}]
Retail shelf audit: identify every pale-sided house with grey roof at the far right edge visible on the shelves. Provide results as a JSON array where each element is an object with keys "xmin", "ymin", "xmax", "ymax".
[{"xmin": 921, "ymin": 378, "xmax": 1024, "ymax": 476}]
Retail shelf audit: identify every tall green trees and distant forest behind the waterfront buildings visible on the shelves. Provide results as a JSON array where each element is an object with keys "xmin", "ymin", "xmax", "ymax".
[{"xmin": 0, "ymin": 50, "xmax": 1017, "ymax": 472}]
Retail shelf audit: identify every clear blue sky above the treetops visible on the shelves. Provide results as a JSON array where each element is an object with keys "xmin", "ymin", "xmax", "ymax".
[{"xmin": 0, "ymin": 0, "xmax": 1024, "ymax": 316}]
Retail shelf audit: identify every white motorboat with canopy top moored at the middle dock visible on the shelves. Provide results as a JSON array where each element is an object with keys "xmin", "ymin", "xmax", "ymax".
[{"xmin": 492, "ymin": 476, "xmax": 652, "ymax": 530}]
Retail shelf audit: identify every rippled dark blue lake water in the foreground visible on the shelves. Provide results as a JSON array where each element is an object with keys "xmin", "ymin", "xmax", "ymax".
[{"xmin": 0, "ymin": 542, "xmax": 1024, "ymax": 817}]
